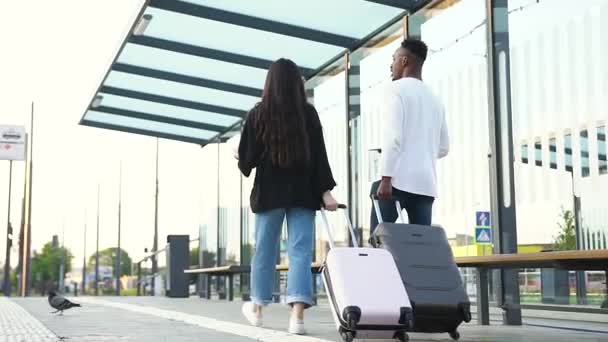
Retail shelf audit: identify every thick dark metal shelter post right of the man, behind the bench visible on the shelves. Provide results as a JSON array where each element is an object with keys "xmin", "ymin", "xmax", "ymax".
[{"xmin": 486, "ymin": 0, "xmax": 522, "ymax": 325}]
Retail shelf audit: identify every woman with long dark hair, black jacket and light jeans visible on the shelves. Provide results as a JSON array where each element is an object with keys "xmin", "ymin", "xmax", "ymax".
[{"xmin": 238, "ymin": 59, "xmax": 338, "ymax": 334}]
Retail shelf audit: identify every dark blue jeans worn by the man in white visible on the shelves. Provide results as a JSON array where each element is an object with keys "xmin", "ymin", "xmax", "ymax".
[{"xmin": 370, "ymin": 181, "xmax": 435, "ymax": 235}]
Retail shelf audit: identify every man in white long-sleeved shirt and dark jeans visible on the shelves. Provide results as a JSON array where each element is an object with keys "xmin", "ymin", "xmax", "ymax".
[{"xmin": 371, "ymin": 39, "xmax": 449, "ymax": 232}]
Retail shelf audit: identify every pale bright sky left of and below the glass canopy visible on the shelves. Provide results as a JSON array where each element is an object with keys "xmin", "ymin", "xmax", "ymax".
[{"xmin": 0, "ymin": 0, "xmax": 205, "ymax": 267}]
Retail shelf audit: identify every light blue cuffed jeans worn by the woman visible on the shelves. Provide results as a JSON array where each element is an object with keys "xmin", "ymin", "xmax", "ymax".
[{"xmin": 251, "ymin": 208, "xmax": 315, "ymax": 307}]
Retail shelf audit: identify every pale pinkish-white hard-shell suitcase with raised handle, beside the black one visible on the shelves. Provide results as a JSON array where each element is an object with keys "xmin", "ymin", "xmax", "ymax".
[{"xmin": 321, "ymin": 205, "xmax": 414, "ymax": 342}]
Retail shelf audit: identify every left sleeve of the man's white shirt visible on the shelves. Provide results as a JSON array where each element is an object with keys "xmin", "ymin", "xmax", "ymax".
[{"xmin": 380, "ymin": 87, "xmax": 406, "ymax": 177}]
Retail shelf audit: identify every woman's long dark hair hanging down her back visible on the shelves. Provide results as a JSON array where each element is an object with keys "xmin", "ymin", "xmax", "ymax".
[{"xmin": 256, "ymin": 58, "xmax": 311, "ymax": 168}]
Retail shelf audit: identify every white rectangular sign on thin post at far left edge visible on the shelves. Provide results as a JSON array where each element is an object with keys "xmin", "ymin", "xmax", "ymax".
[{"xmin": 0, "ymin": 126, "xmax": 25, "ymax": 297}]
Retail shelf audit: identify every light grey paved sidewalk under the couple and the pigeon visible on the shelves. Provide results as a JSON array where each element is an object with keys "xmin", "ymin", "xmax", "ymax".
[{"xmin": 0, "ymin": 297, "xmax": 608, "ymax": 342}]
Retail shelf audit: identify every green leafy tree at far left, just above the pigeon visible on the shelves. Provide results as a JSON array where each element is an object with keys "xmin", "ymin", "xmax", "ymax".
[{"xmin": 32, "ymin": 242, "xmax": 74, "ymax": 294}]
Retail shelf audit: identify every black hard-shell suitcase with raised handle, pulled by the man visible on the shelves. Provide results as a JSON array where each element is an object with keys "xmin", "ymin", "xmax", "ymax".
[{"xmin": 370, "ymin": 199, "xmax": 471, "ymax": 340}]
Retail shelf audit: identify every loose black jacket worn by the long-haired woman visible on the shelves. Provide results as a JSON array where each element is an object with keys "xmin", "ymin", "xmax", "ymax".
[{"xmin": 238, "ymin": 105, "xmax": 336, "ymax": 213}]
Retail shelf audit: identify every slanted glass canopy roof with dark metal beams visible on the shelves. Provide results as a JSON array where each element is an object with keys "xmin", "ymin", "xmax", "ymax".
[{"xmin": 80, "ymin": 0, "xmax": 428, "ymax": 145}]
